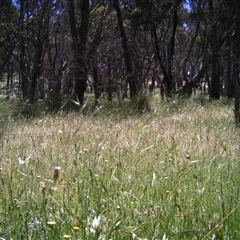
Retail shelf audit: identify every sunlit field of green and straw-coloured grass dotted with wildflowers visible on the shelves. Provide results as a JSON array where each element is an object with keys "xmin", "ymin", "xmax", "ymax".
[{"xmin": 0, "ymin": 96, "xmax": 240, "ymax": 240}]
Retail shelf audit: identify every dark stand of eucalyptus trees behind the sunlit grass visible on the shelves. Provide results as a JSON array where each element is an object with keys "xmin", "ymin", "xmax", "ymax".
[{"xmin": 0, "ymin": 0, "xmax": 240, "ymax": 119}]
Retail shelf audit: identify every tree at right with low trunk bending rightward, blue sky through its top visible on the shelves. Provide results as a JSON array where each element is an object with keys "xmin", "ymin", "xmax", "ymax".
[{"xmin": 177, "ymin": 0, "xmax": 210, "ymax": 96}]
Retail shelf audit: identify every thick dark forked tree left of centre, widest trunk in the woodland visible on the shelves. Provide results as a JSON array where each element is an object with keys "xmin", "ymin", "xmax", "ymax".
[{"xmin": 66, "ymin": 0, "xmax": 110, "ymax": 104}]
